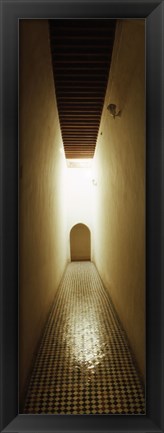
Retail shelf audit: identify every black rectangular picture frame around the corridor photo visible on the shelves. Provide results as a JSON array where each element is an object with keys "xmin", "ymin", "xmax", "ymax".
[{"xmin": 0, "ymin": 0, "xmax": 164, "ymax": 433}]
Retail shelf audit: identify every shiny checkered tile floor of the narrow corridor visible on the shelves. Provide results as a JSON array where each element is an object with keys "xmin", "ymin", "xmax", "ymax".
[{"xmin": 24, "ymin": 262, "xmax": 145, "ymax": 414}]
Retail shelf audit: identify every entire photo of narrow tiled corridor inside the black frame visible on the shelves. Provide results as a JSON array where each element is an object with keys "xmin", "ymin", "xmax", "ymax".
[{"xmin": 19, "ymin": 17, "xmax": 145, "ymax": 415}]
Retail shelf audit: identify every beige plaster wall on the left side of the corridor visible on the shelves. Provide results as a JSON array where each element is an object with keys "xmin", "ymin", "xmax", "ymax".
[{"xmin": 19, "ymin": 20, "xmax": 68, "ymax": 404}]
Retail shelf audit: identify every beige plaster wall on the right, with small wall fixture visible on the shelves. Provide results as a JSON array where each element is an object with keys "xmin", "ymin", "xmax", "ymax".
[{"xmin": 93, "ymin": 20, "xmax": 145, "ymax": 376}]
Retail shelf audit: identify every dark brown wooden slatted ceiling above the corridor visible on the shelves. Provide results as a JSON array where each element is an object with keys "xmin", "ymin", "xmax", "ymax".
[{"xmin": 49, "ymin": 19, "xmax": 116, "ymax": 159}]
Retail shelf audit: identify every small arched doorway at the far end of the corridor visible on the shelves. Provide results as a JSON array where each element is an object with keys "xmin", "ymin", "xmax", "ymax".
[{"xmin": 70, "ymin": 223, "xmax": 91, "ymax": 261}]
